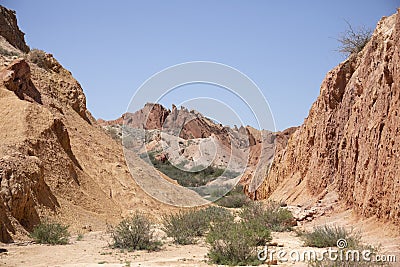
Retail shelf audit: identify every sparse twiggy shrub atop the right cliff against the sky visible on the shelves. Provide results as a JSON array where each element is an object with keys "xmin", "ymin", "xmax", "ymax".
[{"xmin": 337, "ymin": 21, "xmax": 372, "ymax": 56}]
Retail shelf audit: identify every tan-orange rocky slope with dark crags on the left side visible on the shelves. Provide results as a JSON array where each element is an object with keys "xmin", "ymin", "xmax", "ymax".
[{"xmin": 0, "ymin": 7, "xmax": 180, "ymax": 242}]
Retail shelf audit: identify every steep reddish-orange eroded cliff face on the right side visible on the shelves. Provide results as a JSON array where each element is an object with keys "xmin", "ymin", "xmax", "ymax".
[{"xmin": 255, "ymin": 9, "xmax": 400, "ymax": 224}]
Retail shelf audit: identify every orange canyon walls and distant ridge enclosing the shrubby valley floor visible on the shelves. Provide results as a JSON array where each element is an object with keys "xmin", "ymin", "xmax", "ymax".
[{"xmin": 0, "ymin": 6, "xmax": 400, "ymax": 266}]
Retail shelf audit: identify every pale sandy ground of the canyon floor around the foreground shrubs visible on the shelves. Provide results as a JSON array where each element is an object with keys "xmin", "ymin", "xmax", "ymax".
[{"xmin": 0, "ymin": 211, "xmax": 400, "ymax": 267}]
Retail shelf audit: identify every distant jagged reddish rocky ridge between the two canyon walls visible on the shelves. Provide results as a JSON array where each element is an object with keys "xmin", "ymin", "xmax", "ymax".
[{"xmin": 98, "ymin": 103, "xmax": 276, "ymax": 194}]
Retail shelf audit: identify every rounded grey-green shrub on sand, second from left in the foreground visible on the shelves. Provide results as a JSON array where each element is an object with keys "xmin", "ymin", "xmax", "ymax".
[{"xmin": 110, "ymin": 212, "xmax": 161, "ymax": 251}]
